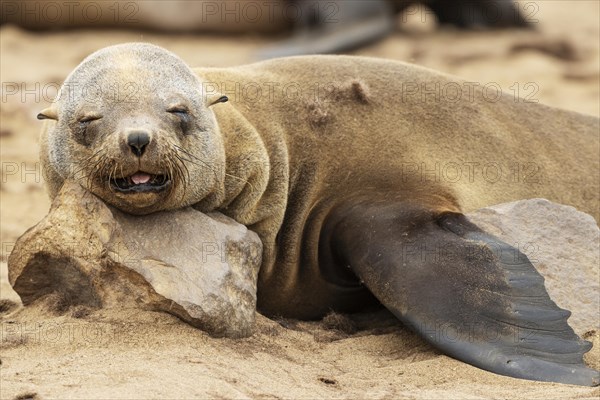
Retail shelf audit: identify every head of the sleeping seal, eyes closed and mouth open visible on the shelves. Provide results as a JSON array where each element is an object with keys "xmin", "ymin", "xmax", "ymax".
[{"xmin": 38, "ymin": 43, "xmax": 225, "ymax": 214}]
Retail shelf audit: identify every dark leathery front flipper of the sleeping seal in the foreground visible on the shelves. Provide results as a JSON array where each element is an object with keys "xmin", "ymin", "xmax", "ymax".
[{"xmin": 323, "ymin": 202, "xmax": 599, "ymax": 386}]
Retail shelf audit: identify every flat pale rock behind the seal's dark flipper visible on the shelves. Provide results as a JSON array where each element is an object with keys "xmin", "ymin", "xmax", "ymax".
[{"xmin": 467, "ymin": 199, "xmax": 600, "ymax": 334}]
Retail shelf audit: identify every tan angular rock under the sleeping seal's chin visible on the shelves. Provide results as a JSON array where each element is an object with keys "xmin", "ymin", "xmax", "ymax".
[{"xmin": 8, "ymin": 183, "xmax": 262, "ymax": 337}]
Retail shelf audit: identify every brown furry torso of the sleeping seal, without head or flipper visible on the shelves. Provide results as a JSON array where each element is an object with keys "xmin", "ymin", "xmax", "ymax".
[{"xmin": 195, "ymin": 56, "xmax": 600, "ymax": 318}]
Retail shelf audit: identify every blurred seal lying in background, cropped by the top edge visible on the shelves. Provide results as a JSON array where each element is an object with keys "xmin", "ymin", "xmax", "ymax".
[{"xmin": 0, "ymin": 0, "xmax": 528, "ymax": 58}]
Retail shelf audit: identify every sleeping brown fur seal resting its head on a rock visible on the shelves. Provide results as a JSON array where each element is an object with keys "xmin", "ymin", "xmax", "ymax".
[{"xmin": 38, "ymin": 43, "xmax": 599, "ymax": 385}]
